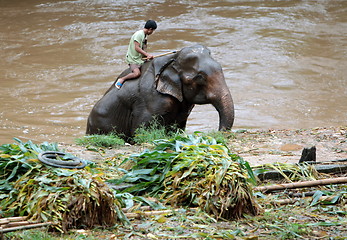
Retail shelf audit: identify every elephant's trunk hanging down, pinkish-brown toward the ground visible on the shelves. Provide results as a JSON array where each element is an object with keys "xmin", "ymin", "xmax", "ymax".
[{"xmin": 212, "ymin": 89, "xmax": 235, "ymax": 131}]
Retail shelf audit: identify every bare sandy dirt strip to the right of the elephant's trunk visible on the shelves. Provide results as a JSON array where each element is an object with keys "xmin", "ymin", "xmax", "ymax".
[{"xmin": 230, "ymin": 127, "xmax": 347, "ymax": 165}]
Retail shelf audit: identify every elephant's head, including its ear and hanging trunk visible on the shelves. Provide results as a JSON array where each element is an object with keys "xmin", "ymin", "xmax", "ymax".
[{"xmin": 154, "ymin": 45, "xmax": 234, "ymax": 130}]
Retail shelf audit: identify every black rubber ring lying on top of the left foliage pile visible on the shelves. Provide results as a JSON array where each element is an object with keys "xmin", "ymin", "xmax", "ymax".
[{"xmin": 38, "ymin": 151, "xmax": 87, "ymax": 168}]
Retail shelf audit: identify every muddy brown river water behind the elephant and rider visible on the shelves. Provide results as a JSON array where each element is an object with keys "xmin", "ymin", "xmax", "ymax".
[{"xmin": 0, "ymin": 0, "xmax": 347, "ymax": 144}]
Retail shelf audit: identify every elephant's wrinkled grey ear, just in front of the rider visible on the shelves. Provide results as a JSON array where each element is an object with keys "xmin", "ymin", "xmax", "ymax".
[{"xmin": 155, "ymin": 55, "xmax": 183, "ymax": 102}]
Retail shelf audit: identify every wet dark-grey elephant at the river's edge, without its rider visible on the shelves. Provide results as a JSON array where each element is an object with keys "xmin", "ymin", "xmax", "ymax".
[{"xmin": 86, "ymin": 45, "xmax": 234, "ymax": 138}]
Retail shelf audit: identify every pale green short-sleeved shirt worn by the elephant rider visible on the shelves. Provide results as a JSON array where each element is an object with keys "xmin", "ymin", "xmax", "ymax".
[{"xmin": 126, "ymin": 30, "xmax": 146, "ymax": 65}]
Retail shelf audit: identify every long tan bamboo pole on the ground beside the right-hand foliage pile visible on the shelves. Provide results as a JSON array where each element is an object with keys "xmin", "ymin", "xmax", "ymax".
[{"xmin": 253, "ymin": 177, "xmax": 347, "ymax": 193}]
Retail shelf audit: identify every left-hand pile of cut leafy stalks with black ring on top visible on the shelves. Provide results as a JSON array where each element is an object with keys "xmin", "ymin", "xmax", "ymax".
[{"xmin": 0, "ymin": 139, "xmax": 120, "ymax": 232}]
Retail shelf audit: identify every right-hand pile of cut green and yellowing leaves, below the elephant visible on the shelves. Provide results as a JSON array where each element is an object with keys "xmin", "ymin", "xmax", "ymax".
[{"xmin": 109, "ymin": 133, "xmax": 260, "ymax": 220}]
